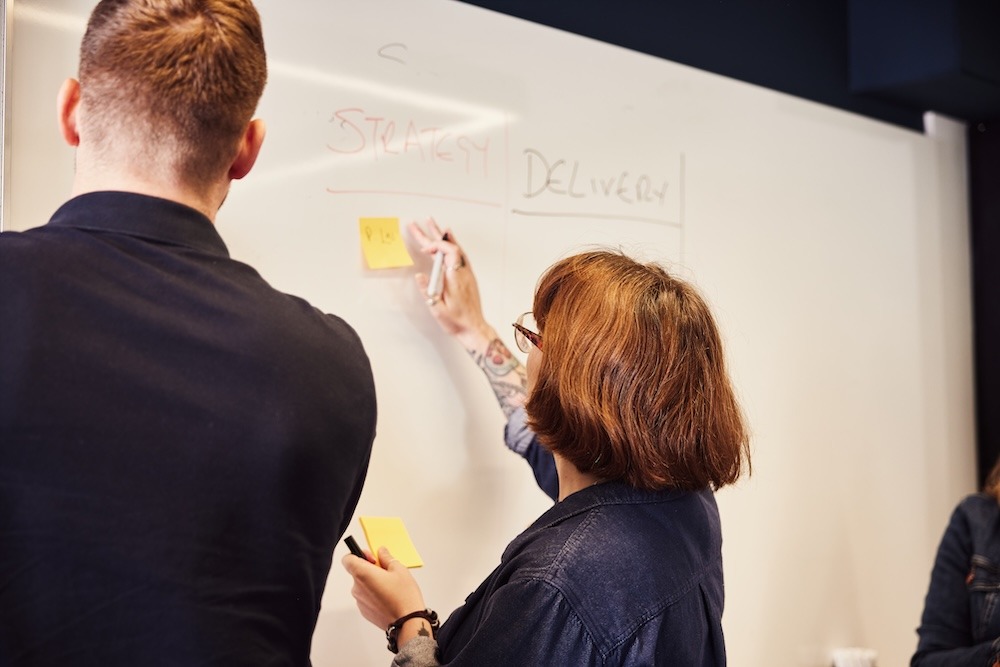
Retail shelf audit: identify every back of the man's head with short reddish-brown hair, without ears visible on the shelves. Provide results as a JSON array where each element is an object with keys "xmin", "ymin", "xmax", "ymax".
[{"xmin": 77, "ymin": 0, "xmax": 267, "ymax": 190}]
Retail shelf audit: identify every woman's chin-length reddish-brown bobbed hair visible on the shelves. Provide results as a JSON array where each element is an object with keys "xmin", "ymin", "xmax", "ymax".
[{"xmin": 526, "ymin": 251, "xmax": 750, "ymax": 489}]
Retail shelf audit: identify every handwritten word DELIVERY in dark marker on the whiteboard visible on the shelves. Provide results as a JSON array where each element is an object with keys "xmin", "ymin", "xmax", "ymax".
[{"xmin": 523, "ymin": 148, "xmax": 667, "ymax": 206}]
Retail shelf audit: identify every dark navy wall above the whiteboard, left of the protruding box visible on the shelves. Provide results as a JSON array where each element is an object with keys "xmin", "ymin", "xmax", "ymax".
[{"xmin": 456, "ymin": 0, "xmax": 922, "ymax": 129}]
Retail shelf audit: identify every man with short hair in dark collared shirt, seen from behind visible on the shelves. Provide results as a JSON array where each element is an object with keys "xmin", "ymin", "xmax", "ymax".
[{"xmin": 0, "ymin": 0, "xmax": 376, "ymax": 667}]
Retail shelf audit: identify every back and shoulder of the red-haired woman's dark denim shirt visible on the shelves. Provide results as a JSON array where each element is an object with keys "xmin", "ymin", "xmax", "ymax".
[{"xmin": 438, "ymin": 482, "xmax": 726, "ymax": 667}]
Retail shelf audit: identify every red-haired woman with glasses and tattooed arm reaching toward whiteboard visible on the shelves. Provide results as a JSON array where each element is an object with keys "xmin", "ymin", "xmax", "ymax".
[{"xmin": 343, "ymin": 226, "xmax": 749, "ymax": 667}]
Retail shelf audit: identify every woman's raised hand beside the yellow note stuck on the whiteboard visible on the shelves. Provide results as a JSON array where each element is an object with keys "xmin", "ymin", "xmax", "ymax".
[{"xmin": 409, "ymin": 219, "xmax": 496, "ymax": 350}]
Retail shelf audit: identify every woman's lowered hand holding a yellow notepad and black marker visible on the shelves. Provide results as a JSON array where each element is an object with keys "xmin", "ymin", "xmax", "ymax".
[{"xmin": 340, "ymin": 547, "xmax": 426, "ymax": 632}]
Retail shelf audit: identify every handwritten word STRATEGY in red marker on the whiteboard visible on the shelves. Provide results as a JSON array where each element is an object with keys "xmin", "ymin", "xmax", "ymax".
[{"xmin": 327, "ymin": 108, "xmax": 490, "ymax": 178}]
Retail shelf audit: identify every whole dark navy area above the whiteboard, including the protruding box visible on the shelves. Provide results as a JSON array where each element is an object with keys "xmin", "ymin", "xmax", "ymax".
[{"xmin": 464, "ymin": 0, "xmax": 1000, "ymax": 130}]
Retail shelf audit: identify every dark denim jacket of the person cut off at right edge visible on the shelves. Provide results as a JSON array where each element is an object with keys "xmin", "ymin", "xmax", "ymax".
[{"xmin": 910, "ymin": 494, "xmax": 1000, "ymax": 667}]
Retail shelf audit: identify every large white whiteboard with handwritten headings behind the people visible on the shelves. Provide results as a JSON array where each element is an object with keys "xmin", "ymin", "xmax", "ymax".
[{"xmin": 3, "ymin": 0, "xmax": 974, "ymax": 667}]
